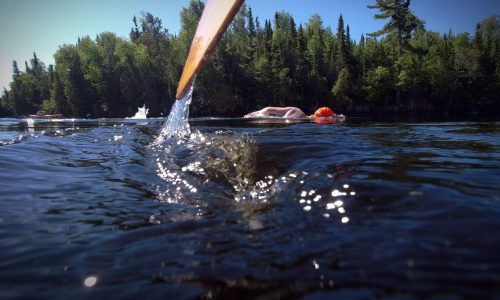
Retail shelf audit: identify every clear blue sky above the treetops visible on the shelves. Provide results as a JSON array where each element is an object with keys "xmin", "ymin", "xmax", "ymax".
[{"xmin": 0, "ymin": 0, "xmax": 500, "ymax": 90}]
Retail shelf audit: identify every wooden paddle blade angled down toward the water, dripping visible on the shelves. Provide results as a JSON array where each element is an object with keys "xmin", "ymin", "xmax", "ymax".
[{"xmin": 175, "ymin": 0, "xmax": 243, "ymax": 100}]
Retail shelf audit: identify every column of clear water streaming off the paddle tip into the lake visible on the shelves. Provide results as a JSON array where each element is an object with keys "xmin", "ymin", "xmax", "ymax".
[{"xmin": 156, "ymin": 80, "xmax": 194, "ymax": 144}]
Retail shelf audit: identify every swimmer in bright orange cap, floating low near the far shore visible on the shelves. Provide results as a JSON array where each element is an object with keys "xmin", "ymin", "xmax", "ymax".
[{"xmin": 244, "ymin": 106, "xmax": 335, "ymax": 119}]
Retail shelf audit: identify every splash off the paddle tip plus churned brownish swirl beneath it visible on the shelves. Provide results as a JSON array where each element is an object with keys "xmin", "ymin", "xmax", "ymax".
[{"xmin": 151, "ymin": 85, "xmax": 264, "ymax": 203}]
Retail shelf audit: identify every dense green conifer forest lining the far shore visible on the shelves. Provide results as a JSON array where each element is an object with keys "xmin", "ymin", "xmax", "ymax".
[{"xmin": 0, "ymin": 0, "xmax": 500, "ymax": 118}]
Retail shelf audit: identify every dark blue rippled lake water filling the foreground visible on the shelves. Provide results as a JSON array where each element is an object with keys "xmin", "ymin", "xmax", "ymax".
[{"xmin": 0, "ymin": 118, "xmax": 500, "ymax": 299}]
